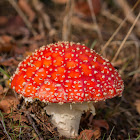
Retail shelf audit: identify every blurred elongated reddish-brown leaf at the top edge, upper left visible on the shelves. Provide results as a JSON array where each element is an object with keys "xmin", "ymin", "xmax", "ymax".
[{"xmin": 18, "ymin": 0, "xmax": 35, "ymax": 22}]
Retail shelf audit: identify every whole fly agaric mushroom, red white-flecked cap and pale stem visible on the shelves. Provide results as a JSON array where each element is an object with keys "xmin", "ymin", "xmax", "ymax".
[{"xmin": 11, "ymin": 42, "xmax": 124, "ymax": 138}]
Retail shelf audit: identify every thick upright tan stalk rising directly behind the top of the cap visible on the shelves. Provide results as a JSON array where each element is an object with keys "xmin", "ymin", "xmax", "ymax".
[{"xmin": 62, "ymin": 0, "xmax": 74, "ymax": 41}]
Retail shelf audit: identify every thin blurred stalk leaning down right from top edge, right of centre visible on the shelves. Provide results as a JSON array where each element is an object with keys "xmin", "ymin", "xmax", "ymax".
[{"xmin": 87, "ymin": 0, "xmax": 103, "ymax": 41}]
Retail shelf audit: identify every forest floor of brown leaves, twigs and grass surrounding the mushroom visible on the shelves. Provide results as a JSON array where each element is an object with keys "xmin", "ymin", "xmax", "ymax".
[{"xmin": 0, "ymin": 0, "xmax": 140, "ymax": 140}]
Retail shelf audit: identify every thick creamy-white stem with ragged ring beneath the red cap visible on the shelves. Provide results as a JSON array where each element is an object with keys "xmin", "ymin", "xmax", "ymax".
[{"xmin": 45, "ymin": 102, "xmax": 95, "ymax": 138}]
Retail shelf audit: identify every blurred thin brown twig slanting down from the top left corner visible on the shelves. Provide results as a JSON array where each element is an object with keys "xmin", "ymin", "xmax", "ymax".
[{"xmin": 8, "ymin": 0, "xmax": 37, "ymax": 36}]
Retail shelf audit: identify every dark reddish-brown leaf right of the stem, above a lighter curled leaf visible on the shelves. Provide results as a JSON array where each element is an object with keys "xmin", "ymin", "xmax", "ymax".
[{"xmin": 92, "ymin": 120, "xmax": 109, "ymax": 130}]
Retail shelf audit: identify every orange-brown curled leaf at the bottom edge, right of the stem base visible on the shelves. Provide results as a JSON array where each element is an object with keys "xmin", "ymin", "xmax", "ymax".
[{"xmin": 78, "ymin": 128, "xmax": 101, "ymax": 140}]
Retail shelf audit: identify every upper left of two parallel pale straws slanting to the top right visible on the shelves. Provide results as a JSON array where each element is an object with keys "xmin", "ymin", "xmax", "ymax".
[{"xmin": 101, "ymin": 0, "xmax": 140, "ymax": 53}]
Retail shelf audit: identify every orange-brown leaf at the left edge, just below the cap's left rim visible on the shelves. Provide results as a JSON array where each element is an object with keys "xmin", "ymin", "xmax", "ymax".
[{"xmin": 0, "ymin": 95, "xmax": 19, "ymax": 113}]
